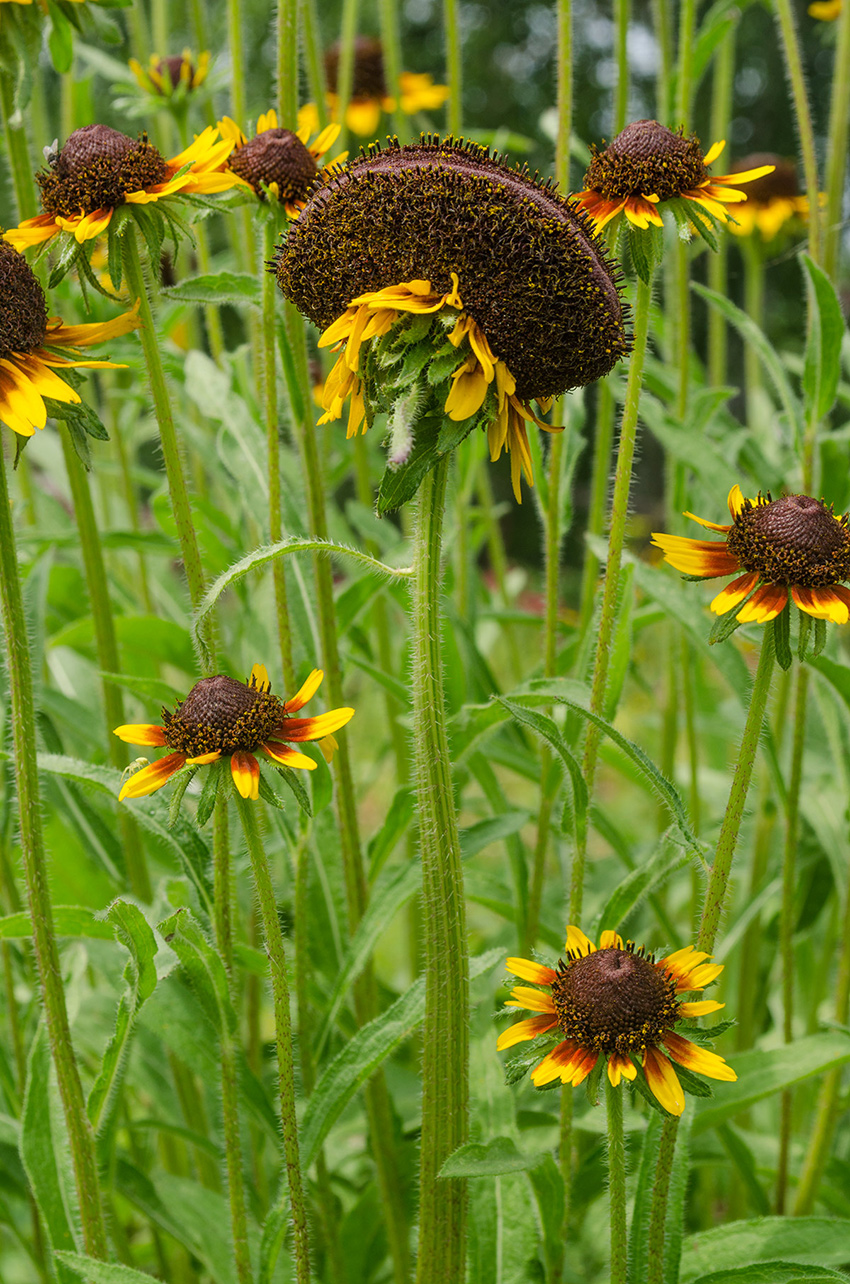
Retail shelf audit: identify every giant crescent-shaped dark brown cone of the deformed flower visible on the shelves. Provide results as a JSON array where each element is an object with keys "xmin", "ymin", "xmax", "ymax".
[{"xmin": 276, "ymin": 136, "xmax": 628, "ymax": 401}]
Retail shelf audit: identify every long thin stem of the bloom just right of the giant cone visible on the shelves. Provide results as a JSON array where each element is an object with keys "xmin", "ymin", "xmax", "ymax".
[{"xmin": 570, "ymin": 281, "xmax": 652, "ymax": 924}]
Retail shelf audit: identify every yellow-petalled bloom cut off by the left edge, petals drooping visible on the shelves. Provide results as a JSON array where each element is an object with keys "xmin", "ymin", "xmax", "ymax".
[{"xmin": 0, "ymin": 240, "xmax": 140, "ymax": 437}]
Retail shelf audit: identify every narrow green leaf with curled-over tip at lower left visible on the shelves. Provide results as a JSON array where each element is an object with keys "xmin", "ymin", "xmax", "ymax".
[{"xmin": 86, "ymin": 900, "xmax": 157, "ymax": 1132}]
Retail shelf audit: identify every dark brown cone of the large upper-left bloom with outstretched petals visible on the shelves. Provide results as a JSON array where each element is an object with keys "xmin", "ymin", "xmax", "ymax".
[{"xmin": 36, "ymin": 125, "xmax": 168, "ymax": 218}]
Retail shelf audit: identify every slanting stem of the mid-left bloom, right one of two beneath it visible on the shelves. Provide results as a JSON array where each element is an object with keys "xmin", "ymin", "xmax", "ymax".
[{"xmin": 235, "ymin": 794, "xmax": 309, "ymax": 1284}]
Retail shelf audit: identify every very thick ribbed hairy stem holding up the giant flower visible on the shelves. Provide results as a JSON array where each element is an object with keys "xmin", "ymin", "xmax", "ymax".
[{"xmin": 411, "ymin": 457, "xmax": 469, "ymax": 1284}]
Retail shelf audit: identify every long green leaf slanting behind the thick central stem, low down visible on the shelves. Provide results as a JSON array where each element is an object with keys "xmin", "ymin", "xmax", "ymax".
[{"xmin": 300, "ymin": 949, "xmax": 505, "ymax": 1170}]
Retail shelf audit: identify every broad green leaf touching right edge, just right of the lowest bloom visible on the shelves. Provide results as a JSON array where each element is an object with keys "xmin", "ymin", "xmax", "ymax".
[{"xmin": 693, "ymin": 1030, "xmax": 850, "ymax": 1135}]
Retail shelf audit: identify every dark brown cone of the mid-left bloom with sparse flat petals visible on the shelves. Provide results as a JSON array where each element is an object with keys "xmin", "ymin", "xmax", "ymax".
[{"xmin": 162, "ymin": 675, "xmax": 284, "ymax": 758}]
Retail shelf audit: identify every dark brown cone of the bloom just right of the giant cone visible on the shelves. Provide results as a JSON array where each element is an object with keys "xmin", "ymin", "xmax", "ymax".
[{"xmin": 584, "ymin": 121, "xmax": 709, "ymax": 200}]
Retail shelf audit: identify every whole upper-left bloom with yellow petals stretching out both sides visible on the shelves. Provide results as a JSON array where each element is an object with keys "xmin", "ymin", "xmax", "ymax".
[{"xmin": 6, "ymin": 125, "xmax": 239, "ymax": 249}]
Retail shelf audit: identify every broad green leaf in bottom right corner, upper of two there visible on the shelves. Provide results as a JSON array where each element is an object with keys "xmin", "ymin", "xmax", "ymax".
[{"xmin": 682, "ymin": 1217, "xmax": 850, "ymax": 1284}]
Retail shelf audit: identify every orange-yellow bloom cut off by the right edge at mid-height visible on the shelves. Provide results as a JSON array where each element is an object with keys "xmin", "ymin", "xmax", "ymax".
[{"xmin": 652, "ymin": 485, "xmax": 850, "ymax": 624}]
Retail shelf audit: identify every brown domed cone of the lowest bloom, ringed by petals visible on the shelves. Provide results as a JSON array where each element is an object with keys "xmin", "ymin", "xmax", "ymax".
[{"xmin": 552, "ymin": 949, "xmax": 678, "ymax": 1054}]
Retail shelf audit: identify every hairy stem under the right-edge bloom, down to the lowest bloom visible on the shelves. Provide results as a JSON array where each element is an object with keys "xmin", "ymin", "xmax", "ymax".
[{"xmin": 696, "ymin": 621, "xmax": 774, "ymax": 954}]
